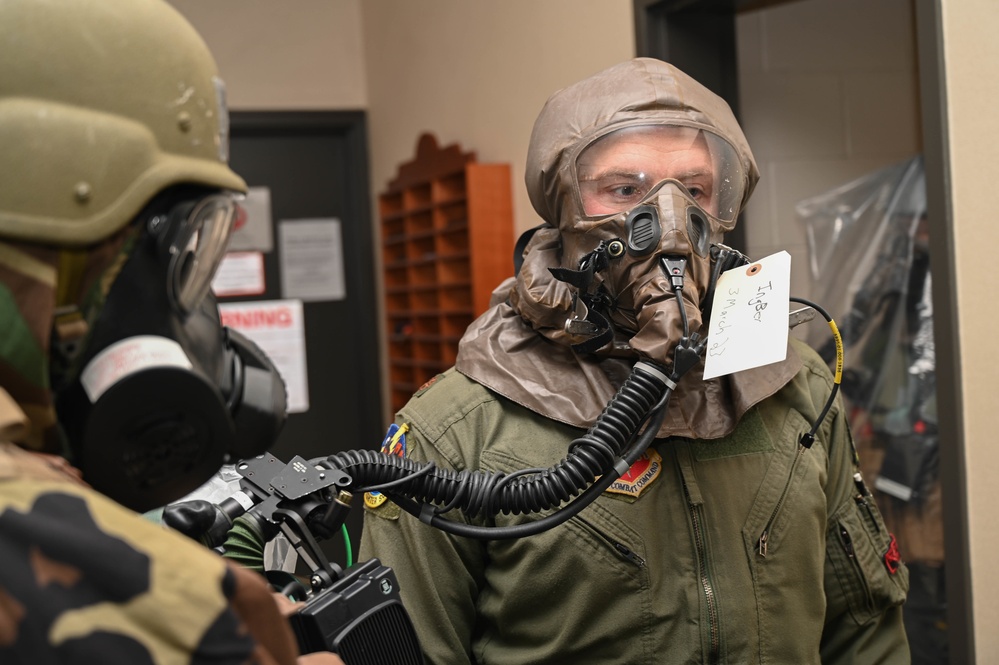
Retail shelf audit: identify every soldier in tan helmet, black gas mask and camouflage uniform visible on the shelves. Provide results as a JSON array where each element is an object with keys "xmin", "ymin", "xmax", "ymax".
[{"xmin": 0, "ymin": 0, "xmax": 340, "ymax": 663}]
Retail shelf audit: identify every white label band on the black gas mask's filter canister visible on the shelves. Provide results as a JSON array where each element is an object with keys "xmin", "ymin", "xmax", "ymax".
[{"xmin": 80, "ymin": 335, "xmax": 191, "ymax": 402}]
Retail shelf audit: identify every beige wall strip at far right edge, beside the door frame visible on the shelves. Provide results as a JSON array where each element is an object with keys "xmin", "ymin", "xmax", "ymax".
[{"xmin": 941, "ymin": 0, "xmax": 999, "ymax": 652}]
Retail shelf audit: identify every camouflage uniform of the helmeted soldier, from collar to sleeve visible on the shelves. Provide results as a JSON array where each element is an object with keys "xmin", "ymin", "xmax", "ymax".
[{"xmin": 0, "ymin": 243, "xmax": 295, "ymax": 665}]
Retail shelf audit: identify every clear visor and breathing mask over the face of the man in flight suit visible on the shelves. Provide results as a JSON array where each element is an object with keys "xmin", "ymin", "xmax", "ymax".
[{"xmin": 518, "ymin": 122, "xmax": 747, "ymax": 364}]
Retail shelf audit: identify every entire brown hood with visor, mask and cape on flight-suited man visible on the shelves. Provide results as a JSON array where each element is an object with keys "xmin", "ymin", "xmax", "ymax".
[{"xmin": 455, "ymin": 58, "xmax": 798, "ymax": 439}]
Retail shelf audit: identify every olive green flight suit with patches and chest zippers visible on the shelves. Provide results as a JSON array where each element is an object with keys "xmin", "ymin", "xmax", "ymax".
[{"xmin": 361, "ymin": 344, "xmax": 909, "ymax": 665}]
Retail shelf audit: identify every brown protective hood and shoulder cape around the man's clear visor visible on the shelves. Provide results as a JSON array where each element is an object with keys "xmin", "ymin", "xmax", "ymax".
[{"xmin": 456, "ymin": 58, "xmax": 800, "ymax": 439}]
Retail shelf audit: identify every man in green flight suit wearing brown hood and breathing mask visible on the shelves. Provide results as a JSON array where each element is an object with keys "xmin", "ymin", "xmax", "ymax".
[{"xmin": 361, "ymin": 58, "xmax": 909, "ymax": 665}]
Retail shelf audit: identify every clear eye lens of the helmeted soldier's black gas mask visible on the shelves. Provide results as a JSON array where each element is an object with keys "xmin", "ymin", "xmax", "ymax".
[{"xmin": 167, "ymin": 193, "xmax": 237, "ymax": 313}]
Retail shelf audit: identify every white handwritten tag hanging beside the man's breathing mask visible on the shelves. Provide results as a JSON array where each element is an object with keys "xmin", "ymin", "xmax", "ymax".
[{"xmin": 704, "ymin": 252, "xmax": 791, "ymax": 379}]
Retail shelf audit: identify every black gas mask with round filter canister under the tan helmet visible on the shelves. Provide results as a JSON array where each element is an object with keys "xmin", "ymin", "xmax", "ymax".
[{"xmin": 55, "ymin": 193, "xmax": 286, "ymax": 511}]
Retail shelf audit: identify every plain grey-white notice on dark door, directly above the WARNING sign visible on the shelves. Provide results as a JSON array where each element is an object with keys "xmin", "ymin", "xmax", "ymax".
[{"xmin": 278, "ymin": 219, "xmax": 347, "ymax": 302}]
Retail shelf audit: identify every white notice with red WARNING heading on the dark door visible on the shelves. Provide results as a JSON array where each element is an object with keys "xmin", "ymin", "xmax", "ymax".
[{"xmin": 219, "ymin": 300, "xmax": 309, "ymax": 413}]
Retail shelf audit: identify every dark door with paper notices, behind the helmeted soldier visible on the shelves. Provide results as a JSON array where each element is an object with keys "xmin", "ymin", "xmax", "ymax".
[{"xmin": 220, "ymin": 111, "xmax": 385, "ymax": 565}]
